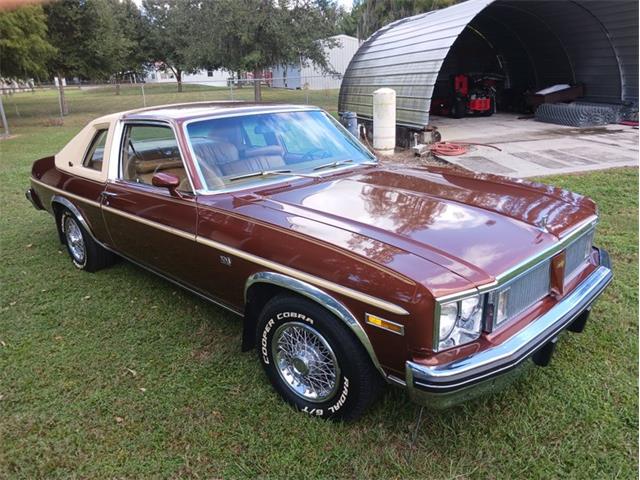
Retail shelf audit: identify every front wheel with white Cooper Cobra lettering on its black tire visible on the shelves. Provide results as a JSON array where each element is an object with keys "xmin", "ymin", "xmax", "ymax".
[{"xmin": 256, "ymin": 295, "xmax": 383, "ymax": 420}]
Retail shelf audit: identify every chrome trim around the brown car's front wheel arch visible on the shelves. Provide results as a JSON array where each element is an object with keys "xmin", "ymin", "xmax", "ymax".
[{"xmin": 244, "ymin": 272, "xmax": 387, "ymax": 380}]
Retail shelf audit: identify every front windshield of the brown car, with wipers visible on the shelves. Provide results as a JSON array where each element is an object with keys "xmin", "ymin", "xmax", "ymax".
[{"xmin": 186, "ymin": 110, "xmax": 375, "ymax": 190}]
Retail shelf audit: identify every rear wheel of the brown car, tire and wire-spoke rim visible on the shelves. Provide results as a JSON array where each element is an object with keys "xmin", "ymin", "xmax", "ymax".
[{"xmin": 58, "ymin": 208, "xmax": 115, "ymax": 272}]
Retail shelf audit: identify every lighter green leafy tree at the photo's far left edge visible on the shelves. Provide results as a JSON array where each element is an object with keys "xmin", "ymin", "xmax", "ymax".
[{"xmin": 0, "ymin": 5, "xmax": 56, "ymax": 79}]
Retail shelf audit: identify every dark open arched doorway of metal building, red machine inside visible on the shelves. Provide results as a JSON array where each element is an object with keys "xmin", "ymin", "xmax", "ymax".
[{"xmin": 431, "ymin": 0, "xmax": 625, "ymax": 117}]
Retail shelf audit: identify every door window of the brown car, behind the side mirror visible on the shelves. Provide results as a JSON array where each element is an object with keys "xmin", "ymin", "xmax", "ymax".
[{"xmin": 120, "ymin": 124, "xmax": 191, "ymax": 191}]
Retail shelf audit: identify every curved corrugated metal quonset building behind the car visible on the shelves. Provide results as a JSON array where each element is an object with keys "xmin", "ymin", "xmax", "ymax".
[{"xmin": 339, "ymin": 0, "xmax": 638, "ymax": 129}]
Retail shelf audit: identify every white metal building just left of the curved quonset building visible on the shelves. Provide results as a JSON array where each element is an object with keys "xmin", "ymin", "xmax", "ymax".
[{"xmin": 272, "ymin": 35, "xmax": 360, "ymax": 90}]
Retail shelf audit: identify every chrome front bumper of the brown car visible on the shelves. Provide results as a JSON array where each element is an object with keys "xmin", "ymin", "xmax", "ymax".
[{"xmin": 405, "ymin": 250, "xmax": 613, "ymax": 408}]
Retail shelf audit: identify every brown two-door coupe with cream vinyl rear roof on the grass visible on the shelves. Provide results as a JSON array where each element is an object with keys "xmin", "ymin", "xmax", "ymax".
[{"xmin": 27, "ymin": 103, "xmax": 612, "ymax": 419}]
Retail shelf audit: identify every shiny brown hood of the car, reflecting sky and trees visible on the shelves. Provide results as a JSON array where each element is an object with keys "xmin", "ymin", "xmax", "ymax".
[{"xmin": 246, "ymin": 167, "xmax": 596, "ymax": 285}]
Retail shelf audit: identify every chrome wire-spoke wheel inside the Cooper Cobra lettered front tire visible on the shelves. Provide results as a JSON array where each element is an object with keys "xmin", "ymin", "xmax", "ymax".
[{"xmin": 271, "ymin": 322, "xmax": 340, "ymax": 403}]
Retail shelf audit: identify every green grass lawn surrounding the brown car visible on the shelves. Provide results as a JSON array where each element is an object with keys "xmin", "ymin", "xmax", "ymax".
[{"xmin": 0, "ymin": 86, "xmax": 638, "ymax": 479}]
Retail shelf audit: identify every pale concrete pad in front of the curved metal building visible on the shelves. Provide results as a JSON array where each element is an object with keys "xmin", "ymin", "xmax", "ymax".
[{"xmin": 431, "ymin": 113, "xmax": 638, "ymax": 177}]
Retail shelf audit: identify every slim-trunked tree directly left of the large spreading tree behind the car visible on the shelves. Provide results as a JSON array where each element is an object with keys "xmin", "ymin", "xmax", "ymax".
[{"xmin": 142, "ymin": 0, "xmax": 199, "ymax": 92}]
